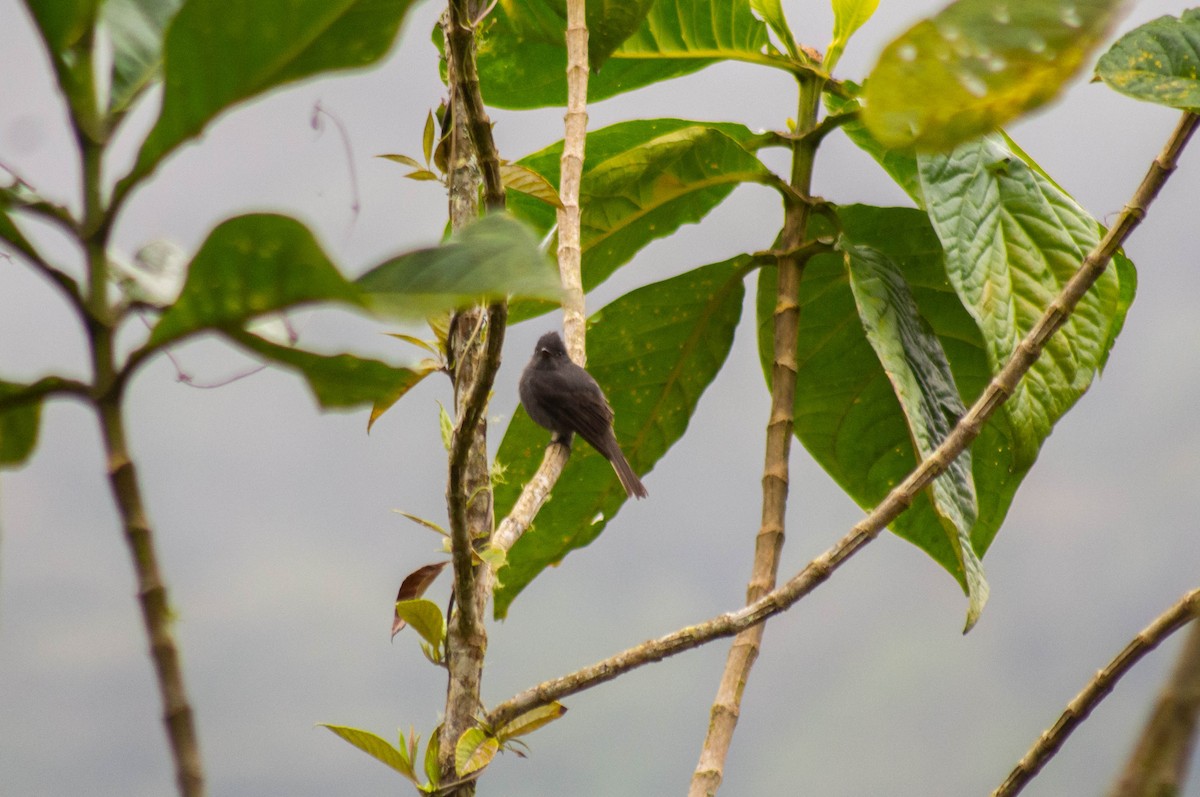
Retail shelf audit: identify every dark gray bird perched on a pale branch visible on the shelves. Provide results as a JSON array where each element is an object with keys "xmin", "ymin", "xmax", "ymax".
[{"xmin": 520, "ymin": 332, "xmax": 648, "ymax": 498}]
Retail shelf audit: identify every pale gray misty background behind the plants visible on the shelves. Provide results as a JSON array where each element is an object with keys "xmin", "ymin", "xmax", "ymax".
[{"xmin": 0, "ymin": 0, "xmax": 1200, "ymax": 797}]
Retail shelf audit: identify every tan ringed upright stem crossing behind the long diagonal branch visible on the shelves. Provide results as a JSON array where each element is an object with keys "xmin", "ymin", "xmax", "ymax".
[{"xmin": 688, "ymin": 78, "xmax": 821, "ymax": 797}]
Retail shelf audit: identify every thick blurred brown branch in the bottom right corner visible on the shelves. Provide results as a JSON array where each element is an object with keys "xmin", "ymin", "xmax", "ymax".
[{"xmin": 1109, "ymin": 623, "xmax": 1200, "ymax": 797}]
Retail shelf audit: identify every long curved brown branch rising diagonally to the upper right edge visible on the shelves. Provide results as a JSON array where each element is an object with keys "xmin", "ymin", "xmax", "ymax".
[{"xmin": 487, "ymin": 107, "xmax": 1200, "ymax": 726}]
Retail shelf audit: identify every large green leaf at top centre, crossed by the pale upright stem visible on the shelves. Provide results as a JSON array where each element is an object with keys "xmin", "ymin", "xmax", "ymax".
[{"xmin": 468, "ymin": 0, "xmax": 772, "ymax": 108}]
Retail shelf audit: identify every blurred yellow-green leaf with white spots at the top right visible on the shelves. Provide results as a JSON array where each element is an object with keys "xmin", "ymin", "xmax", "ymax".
[{"xmin": 863, "ymin": 0, "xmax": 1123, "ymax": 150}]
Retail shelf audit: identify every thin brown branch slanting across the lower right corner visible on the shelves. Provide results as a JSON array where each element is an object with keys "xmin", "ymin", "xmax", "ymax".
[{"xmin": 991, "ymin": 589, "xmax": 1200, "ymax": 797}]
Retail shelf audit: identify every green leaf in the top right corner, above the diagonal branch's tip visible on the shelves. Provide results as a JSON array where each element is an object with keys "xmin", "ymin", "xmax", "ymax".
[{"xmin": 1096, "ymin": 8, "xmax": 1200, "ymax": 110}]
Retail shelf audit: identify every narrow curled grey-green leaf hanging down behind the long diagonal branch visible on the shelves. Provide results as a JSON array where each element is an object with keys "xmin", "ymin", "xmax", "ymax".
[{"xmin": 841, "ymin": 238, "xmax": 988, "ymax": 630}]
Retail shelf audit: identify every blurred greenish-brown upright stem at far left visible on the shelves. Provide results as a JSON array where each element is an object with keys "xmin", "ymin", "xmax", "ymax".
[{"xmin": 77, "ymin": 134, "xmax": 204, "ymax": 797}]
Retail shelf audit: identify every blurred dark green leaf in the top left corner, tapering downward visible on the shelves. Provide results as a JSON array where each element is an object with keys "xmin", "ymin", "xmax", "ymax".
[{"xmin": 25, "ymin": 0, "xmax": 102, "ymax": 135}]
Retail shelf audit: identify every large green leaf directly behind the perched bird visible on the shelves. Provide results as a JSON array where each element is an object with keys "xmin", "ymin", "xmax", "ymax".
[{"xmin": 494, "ymin": 257, "xmax": 749, "ymax": 617}]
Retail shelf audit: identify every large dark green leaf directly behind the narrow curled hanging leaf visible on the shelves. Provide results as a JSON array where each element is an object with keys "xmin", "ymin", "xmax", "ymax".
[{"xmin": 757, "ymin": 205, "xmax": 984, "ymax": 588}]
